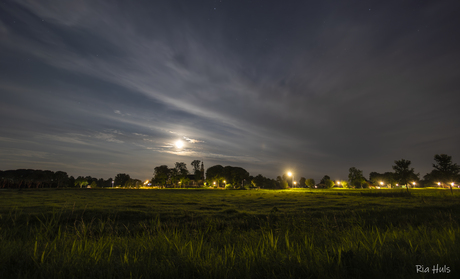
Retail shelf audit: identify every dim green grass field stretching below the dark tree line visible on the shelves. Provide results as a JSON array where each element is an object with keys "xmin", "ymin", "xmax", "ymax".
[{"xmin": 0, "ymin": 189, "xmax": 460, "ymax": 278}]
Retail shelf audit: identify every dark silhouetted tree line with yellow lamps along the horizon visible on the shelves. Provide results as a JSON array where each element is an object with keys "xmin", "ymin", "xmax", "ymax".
[{"xmin": 0, "ymin": 154, "xmax": 460, "ymax": 190}]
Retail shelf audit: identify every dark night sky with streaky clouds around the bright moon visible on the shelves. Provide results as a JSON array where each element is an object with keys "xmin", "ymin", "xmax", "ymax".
[{"xmin": 0, "ymin": 0, "xmax": 460, "ymax": 182}]
